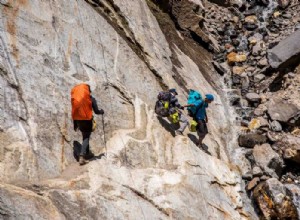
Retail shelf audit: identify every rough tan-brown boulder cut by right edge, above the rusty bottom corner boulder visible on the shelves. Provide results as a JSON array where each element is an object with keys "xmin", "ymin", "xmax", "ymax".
[{"xmin": 274, "ymin": 134, "xmax": 300, "ymax": 164}]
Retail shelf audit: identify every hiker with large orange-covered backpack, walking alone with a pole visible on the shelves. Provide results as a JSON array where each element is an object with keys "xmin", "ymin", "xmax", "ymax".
[{"xmin": 71, "ymin": 84, "xmax": 104, "ymax": 165}]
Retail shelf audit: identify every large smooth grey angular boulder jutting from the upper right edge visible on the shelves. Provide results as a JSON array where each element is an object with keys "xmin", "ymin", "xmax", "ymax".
[{"xmin": 268, "ymin": 30, "xmax": 300, "ymax": 68}]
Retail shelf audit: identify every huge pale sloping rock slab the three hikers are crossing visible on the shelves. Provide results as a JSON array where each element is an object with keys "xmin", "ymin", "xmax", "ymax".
[{"xmin": 0, "ymin": 0, "xmax": 257, "ymax": 219}]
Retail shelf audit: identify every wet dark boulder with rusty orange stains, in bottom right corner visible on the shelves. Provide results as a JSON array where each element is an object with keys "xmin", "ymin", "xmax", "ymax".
[{"xmin": 253, "ymin": 178, "xmax": 298, "ymax": 219}]
